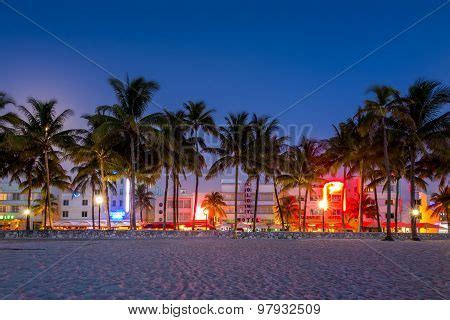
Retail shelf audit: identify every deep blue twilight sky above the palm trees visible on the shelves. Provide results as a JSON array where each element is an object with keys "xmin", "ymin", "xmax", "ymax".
[{"xmin": 0, "ymin": 0, "xmax": 450, "ymax": 194}]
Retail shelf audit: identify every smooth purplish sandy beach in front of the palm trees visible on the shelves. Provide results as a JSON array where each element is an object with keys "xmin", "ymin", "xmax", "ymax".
[{"xmin": 0, "ymin": 238, "xmax": 450, "ymax": 299}]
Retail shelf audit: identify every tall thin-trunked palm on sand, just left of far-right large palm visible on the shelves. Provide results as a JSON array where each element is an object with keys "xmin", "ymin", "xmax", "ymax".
[{"xmin": 359, "ymin": 86, "xmax": 399, "ymax": 241}]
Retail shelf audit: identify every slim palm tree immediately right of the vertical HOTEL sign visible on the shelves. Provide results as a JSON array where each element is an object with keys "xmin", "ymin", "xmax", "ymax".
[{"xmin": 245, "ymin": 114, "xmax": 279, "ymax": 232}]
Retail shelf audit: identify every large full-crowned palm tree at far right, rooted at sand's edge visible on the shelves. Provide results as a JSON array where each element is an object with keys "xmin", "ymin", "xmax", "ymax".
[{"xmin": 396, "ymin": 79, "xmax": 450, "ymax": 241}]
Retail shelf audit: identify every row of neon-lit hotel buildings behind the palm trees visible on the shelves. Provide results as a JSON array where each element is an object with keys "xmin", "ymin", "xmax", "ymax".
[{"xmin": 0, "ymin": 178, "xmax": 447, "ymax": 232}]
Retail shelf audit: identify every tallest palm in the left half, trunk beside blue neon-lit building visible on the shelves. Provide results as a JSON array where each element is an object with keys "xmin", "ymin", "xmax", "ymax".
[{"xmin": 90, "ymin": 77, "xmax": 159, "ymax": 229}]
